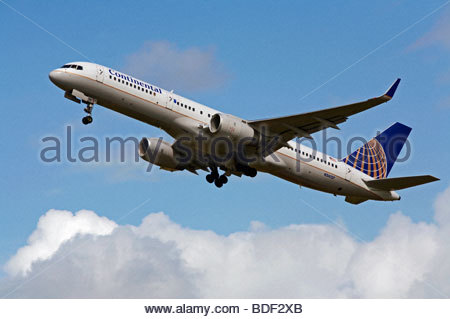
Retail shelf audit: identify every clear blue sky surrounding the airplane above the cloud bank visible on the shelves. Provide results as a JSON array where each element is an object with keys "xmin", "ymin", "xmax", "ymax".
[{"xmin": 0, "ymin": 0, "xmax": 450, "ymax": 294}]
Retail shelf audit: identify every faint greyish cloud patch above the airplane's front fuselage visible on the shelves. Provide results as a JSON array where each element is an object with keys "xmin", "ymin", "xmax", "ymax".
[{"xmin": 124, "ymin": 41, "xmax": 228, "ymax": 91}]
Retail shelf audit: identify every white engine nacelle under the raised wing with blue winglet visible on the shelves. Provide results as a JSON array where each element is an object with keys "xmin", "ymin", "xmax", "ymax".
[{"xmin": 209, "ymin": 113, "xmax": 255, "ymax": 141}]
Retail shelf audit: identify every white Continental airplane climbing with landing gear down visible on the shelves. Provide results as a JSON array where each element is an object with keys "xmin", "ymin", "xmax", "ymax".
[{"xmin": 49, "ymin": 62, "xmax": 439, "ymax": 204}]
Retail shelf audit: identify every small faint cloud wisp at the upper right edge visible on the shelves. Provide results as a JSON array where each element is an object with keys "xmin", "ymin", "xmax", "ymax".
[{"xmin": 411, "ymin": 10, "xmax": 450, "ymax": 50}]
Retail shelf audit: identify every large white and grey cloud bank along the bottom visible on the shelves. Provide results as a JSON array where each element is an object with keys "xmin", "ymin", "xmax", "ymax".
[{"xmin": 0, "ymin": 188, "xmax": 450, "ymax": 298}]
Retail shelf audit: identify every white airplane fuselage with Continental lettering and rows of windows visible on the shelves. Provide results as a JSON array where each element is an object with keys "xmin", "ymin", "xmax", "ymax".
[{"xmin": 50, "ymin": 62, "xmax": 399, "ymax": 200}]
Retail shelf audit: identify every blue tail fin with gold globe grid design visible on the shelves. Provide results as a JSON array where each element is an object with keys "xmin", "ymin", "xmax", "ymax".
[{"xmin": 342, "ymin": 122, "xmax": 411, "ymax": 179}]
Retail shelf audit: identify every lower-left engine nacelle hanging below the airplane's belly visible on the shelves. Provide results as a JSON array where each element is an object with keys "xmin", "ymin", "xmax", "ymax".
[{"xmin": 139, "ymin": 137, "xmax": 179, "ymax": 171}]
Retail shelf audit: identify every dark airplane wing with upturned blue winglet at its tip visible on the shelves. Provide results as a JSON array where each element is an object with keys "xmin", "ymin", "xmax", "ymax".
[{"xmin": 247, "ymin": 79, "xmax": 400, "ymax": 151}]
